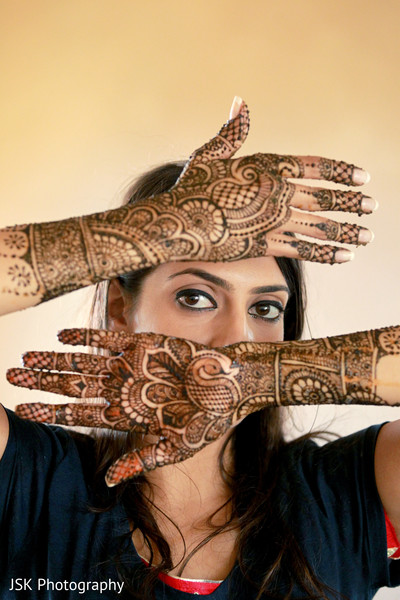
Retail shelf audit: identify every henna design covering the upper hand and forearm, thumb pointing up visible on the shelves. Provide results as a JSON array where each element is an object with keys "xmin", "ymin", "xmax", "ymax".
[{"xmin": 0, "ymin": 103, "xmax": 368, "ymax": 301}]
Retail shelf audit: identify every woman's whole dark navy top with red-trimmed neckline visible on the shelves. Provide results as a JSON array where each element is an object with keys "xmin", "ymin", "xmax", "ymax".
[{"xmin": 0, "ymin": 411, "xmax": 400, "ymax": 600}]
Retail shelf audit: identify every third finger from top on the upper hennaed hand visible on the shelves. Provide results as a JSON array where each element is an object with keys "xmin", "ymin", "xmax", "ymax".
[{"xmin": 276, "ymin": 211, "xmax": 374, "ymax": 245}]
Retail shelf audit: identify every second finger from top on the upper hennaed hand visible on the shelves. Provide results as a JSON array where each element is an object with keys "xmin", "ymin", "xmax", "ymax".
[{"xmin": 290, "ymin": 185, "xmax": 378, "ymax": 216}]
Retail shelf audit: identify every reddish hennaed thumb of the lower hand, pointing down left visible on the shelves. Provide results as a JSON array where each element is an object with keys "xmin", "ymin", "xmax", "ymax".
[{"xmin": 106, "ymin": 439, "xmax": 196, "ymax": 487}]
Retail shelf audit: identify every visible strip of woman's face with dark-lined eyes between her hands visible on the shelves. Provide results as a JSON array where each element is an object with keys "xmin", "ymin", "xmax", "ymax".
[{"xmin": 125, "ymin": 257, "xmax": 289, "ymax": 347}]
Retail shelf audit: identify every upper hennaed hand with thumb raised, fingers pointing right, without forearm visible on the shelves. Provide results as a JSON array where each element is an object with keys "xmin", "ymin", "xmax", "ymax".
[{"xmin": 143, "ymin": 103, "xmax": 375, "ymax": 263}]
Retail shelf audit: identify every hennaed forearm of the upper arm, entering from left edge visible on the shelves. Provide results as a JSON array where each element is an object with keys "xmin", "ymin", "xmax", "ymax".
[{"xmin": 0, "ymin": 204, "xmax": 166, "ymax": 314}]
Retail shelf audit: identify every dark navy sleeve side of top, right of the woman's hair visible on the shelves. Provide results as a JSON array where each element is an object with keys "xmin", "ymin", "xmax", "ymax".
[{"xmin": 282, "ymin": 426, "xmax": 400, "ymax": 598}]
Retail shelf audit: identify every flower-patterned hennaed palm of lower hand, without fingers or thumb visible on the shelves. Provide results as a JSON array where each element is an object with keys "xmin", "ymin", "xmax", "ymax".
[{"xmin": 100, "ymin": 334, "xmax": 240, "ymax": 450}]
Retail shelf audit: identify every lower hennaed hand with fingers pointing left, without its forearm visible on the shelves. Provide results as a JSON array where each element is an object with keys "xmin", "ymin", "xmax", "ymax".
[{"xmin": 8, "ymin": 330, "xmax": 241, "ymax": 485}]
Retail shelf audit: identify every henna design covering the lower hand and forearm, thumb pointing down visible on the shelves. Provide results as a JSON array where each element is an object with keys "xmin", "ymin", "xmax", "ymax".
[{"xmin": 7, "ymin": 327, "xmax": 400, "ymax": 485}]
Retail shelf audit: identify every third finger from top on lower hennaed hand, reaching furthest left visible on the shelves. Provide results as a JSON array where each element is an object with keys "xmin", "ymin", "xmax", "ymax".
[{"xmin": 6, "ymin": 368, "xmax": 107, "ymax": 398}]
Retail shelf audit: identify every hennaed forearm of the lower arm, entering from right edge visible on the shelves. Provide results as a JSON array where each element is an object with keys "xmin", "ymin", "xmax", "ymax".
[{"xmin": 228, "ymin": 327, "xmax": 400, "ymax": 417}]
